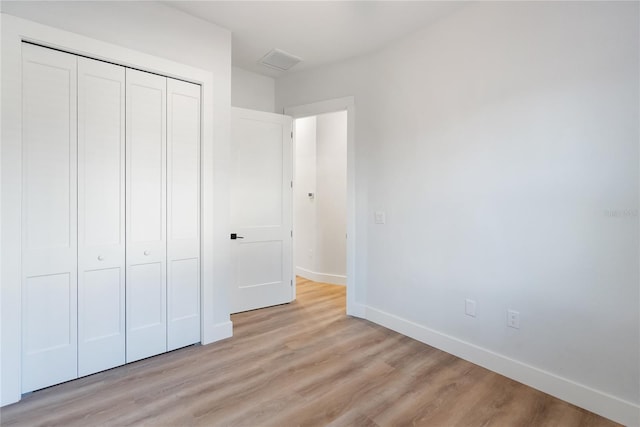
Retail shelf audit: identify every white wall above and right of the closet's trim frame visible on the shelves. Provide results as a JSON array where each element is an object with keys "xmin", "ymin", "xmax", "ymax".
[{"xmin": 1, "ymin": 1, "xmax": 231, "ymax": 403}]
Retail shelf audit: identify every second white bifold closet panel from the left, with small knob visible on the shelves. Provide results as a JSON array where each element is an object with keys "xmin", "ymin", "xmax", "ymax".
[{"xmin": 78, "ymin": 58, "xmax": 125, "ymax": 376}]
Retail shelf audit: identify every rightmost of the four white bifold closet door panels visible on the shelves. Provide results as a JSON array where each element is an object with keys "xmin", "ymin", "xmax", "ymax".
[{"xmin": 167, "ymin": 79, "xmax": 200, "ymax": 350}]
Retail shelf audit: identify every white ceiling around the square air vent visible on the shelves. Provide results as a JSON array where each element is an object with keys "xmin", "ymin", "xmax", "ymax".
[{"xmin": 166, "ymin": 1, "xmax": 465, "ymax": 77}]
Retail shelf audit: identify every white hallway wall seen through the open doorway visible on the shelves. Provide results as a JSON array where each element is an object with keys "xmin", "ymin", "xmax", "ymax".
[{"xmin": 294, "ymin": 111, "xmax": 347, "ymax": 285}]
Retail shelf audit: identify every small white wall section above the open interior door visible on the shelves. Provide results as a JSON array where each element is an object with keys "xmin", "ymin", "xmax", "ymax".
[{"xmin": 231, "ymin": 67, "xmax": 276, "ymax": 113}]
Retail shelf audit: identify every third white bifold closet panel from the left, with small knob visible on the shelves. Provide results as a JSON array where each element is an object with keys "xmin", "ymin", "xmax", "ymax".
[{"xmin": 126, "ymin": 69, "xmax": 167, "ymax": 362}]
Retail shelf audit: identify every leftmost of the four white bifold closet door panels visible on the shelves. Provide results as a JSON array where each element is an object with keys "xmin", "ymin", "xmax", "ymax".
[{"xmin": 22, "ymin": 44, "xmax": 78, "ymax": 392}]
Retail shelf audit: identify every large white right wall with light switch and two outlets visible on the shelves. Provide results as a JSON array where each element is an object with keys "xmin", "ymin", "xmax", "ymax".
[{"xmin": 276, "ymin": 2, "xmax": 640, "ymax": 424}]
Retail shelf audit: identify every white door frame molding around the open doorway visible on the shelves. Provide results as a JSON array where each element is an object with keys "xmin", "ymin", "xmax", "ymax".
[{"xmin": 284, "ymin": 96, "xmax": 365, "ymax": 318}]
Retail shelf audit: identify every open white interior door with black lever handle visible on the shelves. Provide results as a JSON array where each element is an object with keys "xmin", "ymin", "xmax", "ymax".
[{"xmin": 231, "ymin": 108, "xmax": 293, "ymax": 313}]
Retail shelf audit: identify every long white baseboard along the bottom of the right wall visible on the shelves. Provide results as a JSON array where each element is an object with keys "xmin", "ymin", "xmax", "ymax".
[{"xmin": 365, "ymin": 306, "xmax": 640, "ymax": 426}]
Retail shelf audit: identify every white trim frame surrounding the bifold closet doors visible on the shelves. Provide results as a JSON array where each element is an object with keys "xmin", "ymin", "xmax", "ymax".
[{"xmin": 0, "ymin": 14, "xmax": 220, "ymax": 406}]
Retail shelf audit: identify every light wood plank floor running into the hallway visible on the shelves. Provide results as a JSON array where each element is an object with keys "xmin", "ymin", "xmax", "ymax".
[{"xmin": 0, "ymin": 280, "xmax": 615, "ymax": 427}]
